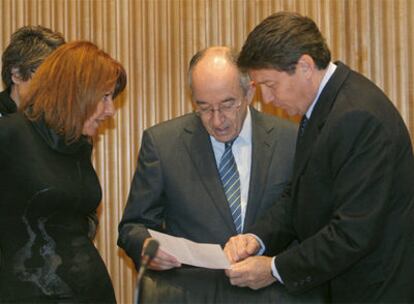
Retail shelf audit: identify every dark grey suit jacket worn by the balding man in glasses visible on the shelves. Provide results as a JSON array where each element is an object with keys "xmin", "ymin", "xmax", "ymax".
[{"xmin": 118, "ymin": 108, "xmax": 297, "ymax": 266}]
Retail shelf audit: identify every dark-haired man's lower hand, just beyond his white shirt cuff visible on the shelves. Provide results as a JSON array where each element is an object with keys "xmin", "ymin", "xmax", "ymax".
[{"xmin": 226, "ymin": 256, "xmax": 277, "ymax": 289}]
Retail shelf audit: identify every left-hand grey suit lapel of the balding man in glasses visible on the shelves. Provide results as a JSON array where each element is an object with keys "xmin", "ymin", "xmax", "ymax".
[{"xmin": 182, "ymin": 115, "xmax": 236, "ymax": 231}]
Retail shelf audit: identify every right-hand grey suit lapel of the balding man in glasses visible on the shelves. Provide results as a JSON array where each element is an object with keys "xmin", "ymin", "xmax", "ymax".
[{"xmin": 244, "ymin": 107, "xmax": 275, "ymax": 227}]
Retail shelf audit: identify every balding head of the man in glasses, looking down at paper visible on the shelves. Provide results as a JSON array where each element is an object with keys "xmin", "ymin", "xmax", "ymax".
[{"xmin": 188, "ymin": 47, "xmax": 255, "ymax": 143}]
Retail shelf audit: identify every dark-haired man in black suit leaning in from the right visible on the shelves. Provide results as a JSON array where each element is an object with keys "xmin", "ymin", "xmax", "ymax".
[{"xmin": 225, "ymin": 12, "xmax": 414, "ymax": 303}]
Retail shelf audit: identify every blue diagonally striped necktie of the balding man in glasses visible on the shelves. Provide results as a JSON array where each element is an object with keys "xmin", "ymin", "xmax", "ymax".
[{"xmin": 219, "ymin": 140, "xmax": 242, "ymax": 233}]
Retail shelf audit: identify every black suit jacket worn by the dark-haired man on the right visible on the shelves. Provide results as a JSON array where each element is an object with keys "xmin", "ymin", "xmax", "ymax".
[{"xmin": 251, "ymin": 63, "xmax": 414, "ymax": 302}]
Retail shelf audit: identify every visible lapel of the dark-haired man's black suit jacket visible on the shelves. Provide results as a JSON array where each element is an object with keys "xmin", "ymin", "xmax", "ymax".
[{"xmin": 293, "ymin": 62, "xmax": 350, "ymax": 185}]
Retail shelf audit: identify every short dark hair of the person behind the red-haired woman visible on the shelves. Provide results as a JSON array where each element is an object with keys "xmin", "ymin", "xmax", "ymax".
[{"xmin": 1, "ymin": 25, "xmax": 65, "ymax": 88}]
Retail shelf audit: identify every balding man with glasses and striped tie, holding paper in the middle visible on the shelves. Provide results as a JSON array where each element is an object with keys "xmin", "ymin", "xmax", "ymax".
[{"xmin": 118, "ymin": 47, "xmax": 308, "ymax": 302}]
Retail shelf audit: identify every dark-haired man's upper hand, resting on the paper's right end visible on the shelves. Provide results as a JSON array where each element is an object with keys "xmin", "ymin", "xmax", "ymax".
[{"xmin": 224, "ymin": 234, "xmax": 260, "ymax": 264}]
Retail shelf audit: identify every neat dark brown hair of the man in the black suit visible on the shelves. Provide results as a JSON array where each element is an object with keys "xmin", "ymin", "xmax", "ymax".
[{"xmin": 237, "ymin": 12, "xmax": 331, "ymax": 73}]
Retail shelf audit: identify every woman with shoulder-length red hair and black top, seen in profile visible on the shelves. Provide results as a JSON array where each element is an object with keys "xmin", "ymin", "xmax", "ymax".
[{"xmin": 0, "ymin": 41, "xmax": 126, "ymax": 303}]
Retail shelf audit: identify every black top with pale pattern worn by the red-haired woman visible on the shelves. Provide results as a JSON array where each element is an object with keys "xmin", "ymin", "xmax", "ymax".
[{"xmin": 0, "ymin": 113, "xmax": 115, "ymax": 303}]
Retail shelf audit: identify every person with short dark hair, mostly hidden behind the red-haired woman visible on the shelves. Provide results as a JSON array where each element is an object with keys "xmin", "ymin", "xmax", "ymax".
[{"xmin": 0, "ymin": 25, "xmax": 65, "ymax": 116}]
